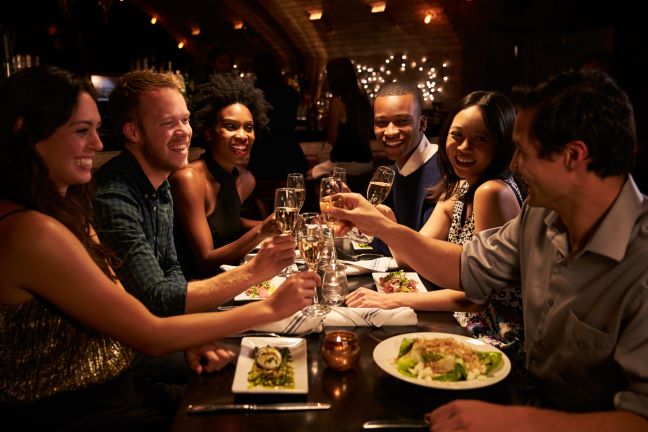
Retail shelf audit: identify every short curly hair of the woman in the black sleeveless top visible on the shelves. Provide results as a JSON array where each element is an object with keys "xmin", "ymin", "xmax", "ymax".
[{"xmin": 189, "ymin": 73, "xmax": 272, "ymax": 141}]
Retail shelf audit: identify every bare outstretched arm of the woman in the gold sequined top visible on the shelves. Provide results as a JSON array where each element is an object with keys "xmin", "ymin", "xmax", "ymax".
[{"xmin": 2, "ymin": 212, "xmax": 319, "ymax": 355}]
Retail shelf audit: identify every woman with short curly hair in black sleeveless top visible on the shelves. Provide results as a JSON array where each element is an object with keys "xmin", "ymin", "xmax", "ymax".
[{"xmin": 170, "ymin": 74, "xmax": 279, "ymax": 279}]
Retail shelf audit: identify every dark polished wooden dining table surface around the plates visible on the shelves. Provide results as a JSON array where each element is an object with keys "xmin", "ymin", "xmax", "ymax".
[{"xmin": 171, "ymin": 268, "xmax": 520, "ymax": 432}]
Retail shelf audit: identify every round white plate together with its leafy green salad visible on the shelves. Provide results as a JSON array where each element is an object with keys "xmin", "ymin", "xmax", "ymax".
[{"xmin": 373, "ymin": 332, "xmax": 511, "ymax": 390}]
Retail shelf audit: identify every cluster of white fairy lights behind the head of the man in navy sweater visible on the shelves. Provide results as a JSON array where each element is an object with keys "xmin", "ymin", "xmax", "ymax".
[{"xmin": 354, "ymin": 53, "xmax": 448, "ymax": 103}]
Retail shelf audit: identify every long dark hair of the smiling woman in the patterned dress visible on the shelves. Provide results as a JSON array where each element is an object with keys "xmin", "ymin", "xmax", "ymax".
[{"xmin": 428, "ymin": 91, "xmax": 520, "ymax": 203}]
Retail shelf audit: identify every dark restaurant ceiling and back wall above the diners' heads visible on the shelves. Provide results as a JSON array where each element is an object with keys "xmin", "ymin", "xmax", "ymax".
[{"xmin": 0, "ymin": 0, "xmax": 647, "ymax": 189}]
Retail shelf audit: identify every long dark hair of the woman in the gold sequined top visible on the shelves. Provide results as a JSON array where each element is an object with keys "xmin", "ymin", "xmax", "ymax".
[{"xmin": 0, "ymin": 66, "xmax": 118, "ymax": 280}]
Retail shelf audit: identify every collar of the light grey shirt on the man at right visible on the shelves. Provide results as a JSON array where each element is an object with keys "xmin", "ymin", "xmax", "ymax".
[{"xmin": 545, "ymin": 176, "xmax": 645, "ymax": 261}]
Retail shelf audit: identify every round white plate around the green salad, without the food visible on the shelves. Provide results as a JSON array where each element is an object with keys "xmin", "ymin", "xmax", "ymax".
[{"xmin": 373, "ymin": 333, "xmax": 511, "ymax": 390}]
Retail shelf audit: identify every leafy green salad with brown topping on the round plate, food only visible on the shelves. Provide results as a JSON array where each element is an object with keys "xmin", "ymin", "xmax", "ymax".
[{"xmin": 396, "ymin": 338, "xmax": 503, "ymax": 381}]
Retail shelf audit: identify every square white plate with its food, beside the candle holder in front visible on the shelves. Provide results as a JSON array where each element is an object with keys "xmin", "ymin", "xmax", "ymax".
[{"xmin": 232, "ymin": 337, "xmax": 308, "ymax": 394}]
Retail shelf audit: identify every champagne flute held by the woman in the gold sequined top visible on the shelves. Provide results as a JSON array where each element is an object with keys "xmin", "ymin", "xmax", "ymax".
[{"xmin": 295, "ymin": 213, "xmax": 331, "ymax": 316}]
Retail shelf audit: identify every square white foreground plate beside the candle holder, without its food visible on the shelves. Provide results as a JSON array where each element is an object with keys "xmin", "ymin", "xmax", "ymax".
[{"xmin": 232, "ymin": 337, "xmax": 308, "ymax": 394}]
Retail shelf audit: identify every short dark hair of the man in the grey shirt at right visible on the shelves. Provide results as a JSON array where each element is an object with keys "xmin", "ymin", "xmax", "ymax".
[{"xmin": 513, "ymin": 69, "xmax": 637, "ymax": 178}]
